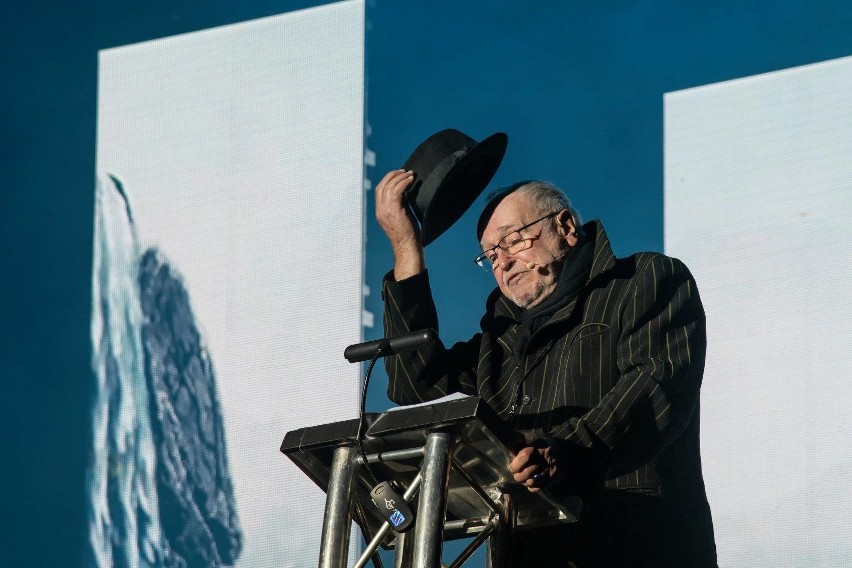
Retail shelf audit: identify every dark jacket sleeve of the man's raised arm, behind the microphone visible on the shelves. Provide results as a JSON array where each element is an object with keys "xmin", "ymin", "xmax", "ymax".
[{"xmin": 382, "ymin": 272, "xmax": 481, "ymax": 404}]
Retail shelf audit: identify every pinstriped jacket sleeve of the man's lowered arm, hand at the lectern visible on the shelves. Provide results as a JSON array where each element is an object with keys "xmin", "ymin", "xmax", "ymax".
[{"xmin": 550, "ymin": 255, "xmax": 706, "ymax": 475}]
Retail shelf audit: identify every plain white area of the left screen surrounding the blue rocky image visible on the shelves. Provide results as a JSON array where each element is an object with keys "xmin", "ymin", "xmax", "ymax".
[{"xmin": 90, "ymin": 1, "xmax": 364, "ymax": 567}]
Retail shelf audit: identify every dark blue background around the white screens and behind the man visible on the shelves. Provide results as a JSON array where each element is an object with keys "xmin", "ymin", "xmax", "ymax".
[{"xmin": 0, "ymin": 0, "xmax": 852, "ymax": 567}]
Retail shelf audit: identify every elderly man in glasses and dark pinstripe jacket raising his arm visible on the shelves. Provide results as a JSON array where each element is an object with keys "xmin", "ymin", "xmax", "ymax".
[{"xmin": 376, "ymin": 170, "xmax": 716, "ymax": 568}]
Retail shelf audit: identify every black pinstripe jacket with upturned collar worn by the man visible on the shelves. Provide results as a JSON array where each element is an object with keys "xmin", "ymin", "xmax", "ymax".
[{"xmin": 383, "ymin": 221, "xmax": 713, "ymax": 564}]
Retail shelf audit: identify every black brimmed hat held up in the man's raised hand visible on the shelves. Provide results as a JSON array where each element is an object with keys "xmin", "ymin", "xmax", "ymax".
[{"xmin": 403, "ymin": 128, "xmax": 509, "ymax": 246}]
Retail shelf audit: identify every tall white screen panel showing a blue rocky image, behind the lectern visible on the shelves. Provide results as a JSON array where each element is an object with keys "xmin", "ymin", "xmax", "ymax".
[{"xmin": 87, "ymin": 1, "xmax": 364, "ymax": 567}]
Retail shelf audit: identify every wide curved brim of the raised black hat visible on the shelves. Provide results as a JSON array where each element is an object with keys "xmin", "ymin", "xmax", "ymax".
[{"xmin": 417, "ymin": 132, "xmax": 509, "ymax": 246}]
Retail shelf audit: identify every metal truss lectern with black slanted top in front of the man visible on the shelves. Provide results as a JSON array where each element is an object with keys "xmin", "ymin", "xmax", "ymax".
[{"xmin": 281, "ymin": 397, "xmax": 582, "ymax": 568}]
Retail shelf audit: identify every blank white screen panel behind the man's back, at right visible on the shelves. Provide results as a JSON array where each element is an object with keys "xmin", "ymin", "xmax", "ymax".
[{"xmin": 665, "ymin": 58, "xmax": 852, "ymax": 568}]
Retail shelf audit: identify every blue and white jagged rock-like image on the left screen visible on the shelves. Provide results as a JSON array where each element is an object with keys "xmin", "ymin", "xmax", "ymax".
[{"xmin": 88, "ymin": 176, "xmax": 242, "ymax": 568}]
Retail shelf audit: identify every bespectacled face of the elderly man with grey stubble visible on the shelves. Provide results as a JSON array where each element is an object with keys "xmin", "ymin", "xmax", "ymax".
[{"xmin": 480, "ymin": 192, "xmax": 577, "ymax": 308}]
